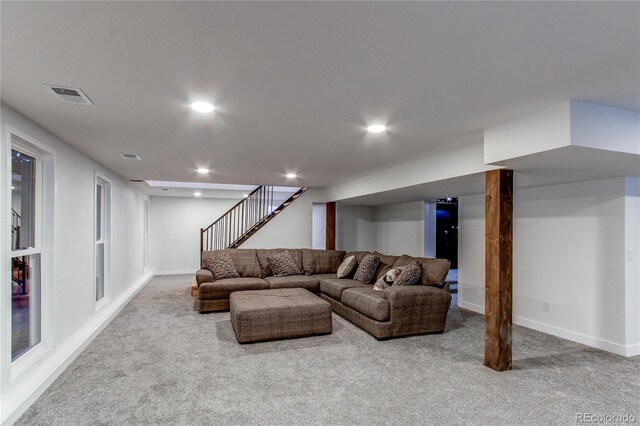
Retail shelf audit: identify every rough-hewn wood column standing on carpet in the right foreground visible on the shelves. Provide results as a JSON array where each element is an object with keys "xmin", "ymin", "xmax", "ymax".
[{"xmin": 484, "ymin": 169, "xmax": 513, "ymax": 371}]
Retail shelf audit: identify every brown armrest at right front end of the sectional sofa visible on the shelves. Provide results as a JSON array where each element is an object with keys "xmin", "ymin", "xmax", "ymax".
[{"xmin": 383, "ymin": 285, "xmax": 451, "ymax": 336}]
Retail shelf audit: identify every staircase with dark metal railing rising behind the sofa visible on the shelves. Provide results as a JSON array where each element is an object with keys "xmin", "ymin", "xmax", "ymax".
[{"xmin": 200, "ymin": 185, "xmax": 309, "ymax": 257}]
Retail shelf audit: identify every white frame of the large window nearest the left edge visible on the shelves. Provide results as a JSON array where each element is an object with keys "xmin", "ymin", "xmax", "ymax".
[{"xmin": 0, "ymin": 125, "xmax": 55, "ymax": 385}]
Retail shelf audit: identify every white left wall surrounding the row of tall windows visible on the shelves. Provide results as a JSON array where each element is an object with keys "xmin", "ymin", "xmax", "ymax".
[{"xmin": 0, "ymin": 104, "xmax": 150, "ymax": 422}]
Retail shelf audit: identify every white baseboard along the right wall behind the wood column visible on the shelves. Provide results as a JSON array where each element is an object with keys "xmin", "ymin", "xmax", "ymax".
[{"xmin": 458, "ymin": 299, "xmax": 640, "ymax": 357}]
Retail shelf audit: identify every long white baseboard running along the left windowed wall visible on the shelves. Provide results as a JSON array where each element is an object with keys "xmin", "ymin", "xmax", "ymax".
[{"xmin": 0, "ymin": 272, "xmax": 154, "ymax": 426}]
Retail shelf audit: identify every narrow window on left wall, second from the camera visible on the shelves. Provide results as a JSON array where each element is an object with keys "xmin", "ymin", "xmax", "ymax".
[{"xmin": 95, "ymin": 177, "xmax": 111, "ymax": 302}]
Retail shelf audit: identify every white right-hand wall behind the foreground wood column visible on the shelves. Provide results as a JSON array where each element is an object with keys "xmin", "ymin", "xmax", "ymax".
[{"xmin": 458, "ymin": 178, "xmax": 640, "ymax": 354}]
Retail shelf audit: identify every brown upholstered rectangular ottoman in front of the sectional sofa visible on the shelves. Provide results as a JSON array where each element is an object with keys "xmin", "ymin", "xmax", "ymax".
[{"xmin": 229, "ymin": 288, "xmax": 333, "ymax": 343}]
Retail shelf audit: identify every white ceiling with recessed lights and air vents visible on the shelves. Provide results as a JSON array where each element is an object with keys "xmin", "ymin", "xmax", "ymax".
[{"xmin": 0, "ymin": 1, "xmax": 640, "ymax": 186}]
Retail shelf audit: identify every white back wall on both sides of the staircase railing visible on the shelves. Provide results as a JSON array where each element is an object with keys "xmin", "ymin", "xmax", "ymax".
[{"xmin": 149, "ymin": 189, "xmax": 324, "ymax": 274}]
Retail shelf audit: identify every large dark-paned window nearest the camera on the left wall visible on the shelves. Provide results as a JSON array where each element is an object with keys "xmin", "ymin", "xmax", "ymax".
[{"xmin": 10, "ymin": 142, "xmax": 42, "ymax": 361}]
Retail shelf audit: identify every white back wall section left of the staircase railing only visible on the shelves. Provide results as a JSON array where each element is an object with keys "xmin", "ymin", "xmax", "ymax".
[{"xmin": 149, "ymin": 197, "xmax": 239, "ymax": 274}]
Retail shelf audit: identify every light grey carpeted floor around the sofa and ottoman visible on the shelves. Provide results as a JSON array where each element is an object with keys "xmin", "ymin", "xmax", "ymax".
[{"xmin": 17, "ymin": 275, "xmax": 640, "ymax": 425}]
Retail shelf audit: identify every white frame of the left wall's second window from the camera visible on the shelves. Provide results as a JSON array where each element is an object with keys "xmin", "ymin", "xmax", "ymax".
[{"xmin": 93, "ymin": 171, "xmax": 111, "ymax": 311}]
